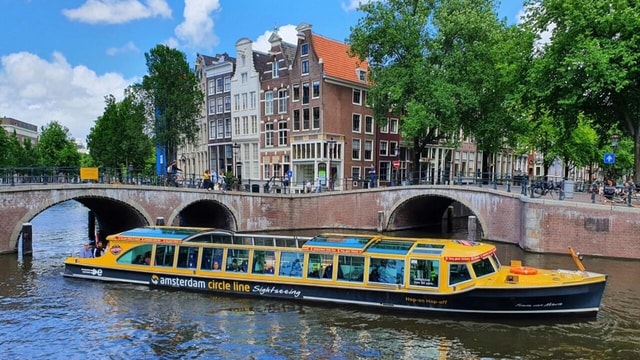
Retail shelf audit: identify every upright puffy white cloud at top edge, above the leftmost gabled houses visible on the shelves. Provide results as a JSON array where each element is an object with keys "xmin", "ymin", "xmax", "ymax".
[{"xmin": 175, "ymin": 0, "xmax": 220, "ymax": 50}]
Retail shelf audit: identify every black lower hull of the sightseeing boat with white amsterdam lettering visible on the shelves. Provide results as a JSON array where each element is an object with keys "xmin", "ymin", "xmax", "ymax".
[{"xmin": 63, "ymin": 263, "xmax": 606, "ymax": 316}]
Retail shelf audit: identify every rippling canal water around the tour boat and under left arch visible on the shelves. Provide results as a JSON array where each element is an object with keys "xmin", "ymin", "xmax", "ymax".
[{"xmin": 0, "ymin": 201, "xmax": 640, "ymax": 360}]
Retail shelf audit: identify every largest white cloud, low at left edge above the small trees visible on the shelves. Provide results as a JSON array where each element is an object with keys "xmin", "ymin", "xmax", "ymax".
[{"xmin": 0, "ymin": 52, "xmax": 139, "ymax": 141}]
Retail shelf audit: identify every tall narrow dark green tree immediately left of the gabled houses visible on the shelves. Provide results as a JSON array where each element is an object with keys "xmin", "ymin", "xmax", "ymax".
[{"xmin": 138, "ymin": 45, "xmax": 204, "ymax": 166}]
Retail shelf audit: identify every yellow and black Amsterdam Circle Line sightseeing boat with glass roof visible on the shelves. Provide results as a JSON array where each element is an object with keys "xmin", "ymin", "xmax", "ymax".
[{"xmin": 63, "ymin": 226, "xmax": 606, "ymax": 316}]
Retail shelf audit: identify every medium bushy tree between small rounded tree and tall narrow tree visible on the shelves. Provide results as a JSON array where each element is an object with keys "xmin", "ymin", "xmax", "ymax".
[{"xmin": 87, "ymin": 94, "xmax": 153, "ymax": 169}]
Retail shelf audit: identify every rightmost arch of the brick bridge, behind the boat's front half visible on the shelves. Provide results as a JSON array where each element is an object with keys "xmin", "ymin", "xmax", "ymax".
[{"xmin": 385, "ymin": 189, "xmax": 486, "ymax": 237}]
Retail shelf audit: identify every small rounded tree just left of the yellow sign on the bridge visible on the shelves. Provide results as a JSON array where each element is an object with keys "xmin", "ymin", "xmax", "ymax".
[{"xmin": 36, "ymin": 121, "xmax": 80, "ymax": 167}]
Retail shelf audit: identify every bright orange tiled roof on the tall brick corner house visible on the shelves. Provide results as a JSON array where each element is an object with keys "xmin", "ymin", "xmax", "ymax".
[{"xmin": 311, "ymin": 34, "xmax": 369, "ymax": 83}]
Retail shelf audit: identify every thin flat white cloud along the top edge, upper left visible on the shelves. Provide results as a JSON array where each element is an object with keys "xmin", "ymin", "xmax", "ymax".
[{"xmin": 62, "ymin": 0, "xmax": 171, "ymax": 24}]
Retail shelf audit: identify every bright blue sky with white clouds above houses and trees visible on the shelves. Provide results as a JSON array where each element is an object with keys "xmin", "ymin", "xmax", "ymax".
[{"xmin": 0, "ymin": 0, "xmax": 523, "ymax": 141}]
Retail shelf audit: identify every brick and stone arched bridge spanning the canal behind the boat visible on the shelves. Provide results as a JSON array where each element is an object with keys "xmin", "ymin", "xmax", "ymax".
[{"xmin": 0, "ymin": 184, "xmax": 640, "ymax": 259}]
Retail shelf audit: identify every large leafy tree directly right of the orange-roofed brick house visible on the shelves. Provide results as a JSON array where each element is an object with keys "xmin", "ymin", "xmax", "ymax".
[{"xmin": 348, "ymin": 0, "xmax": 532, "ymax": 179}]
